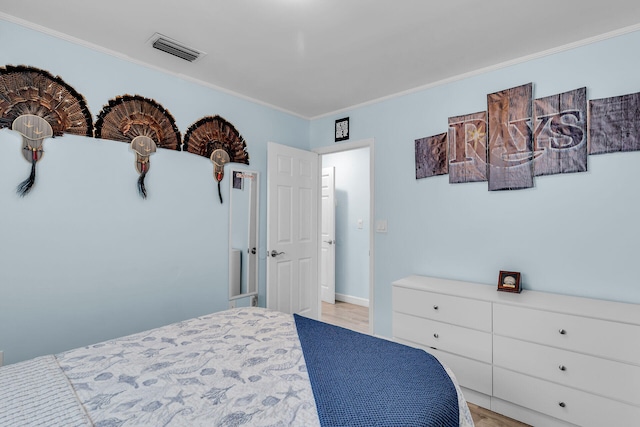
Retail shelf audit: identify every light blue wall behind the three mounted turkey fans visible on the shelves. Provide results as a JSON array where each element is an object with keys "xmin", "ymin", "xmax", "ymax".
[{"xmin": 0, "ymin": 20, "xmax": 309, "ymax": 363}]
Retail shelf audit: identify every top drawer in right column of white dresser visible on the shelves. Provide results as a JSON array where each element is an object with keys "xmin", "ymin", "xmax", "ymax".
[{"xmin": 493, "ymin": 304, "xmax": 640, "ymax": 364}]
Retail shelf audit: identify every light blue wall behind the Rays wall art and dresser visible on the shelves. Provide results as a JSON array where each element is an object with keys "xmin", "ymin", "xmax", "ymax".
[{"xmin": 311, "ymin": 28, "xmax": 640, "ymax": 336}]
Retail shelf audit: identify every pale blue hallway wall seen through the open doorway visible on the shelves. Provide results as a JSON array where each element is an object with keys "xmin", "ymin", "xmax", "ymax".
[{"xmin": 322, "ymin": 148, "xmax": 370, "ymax": 302}]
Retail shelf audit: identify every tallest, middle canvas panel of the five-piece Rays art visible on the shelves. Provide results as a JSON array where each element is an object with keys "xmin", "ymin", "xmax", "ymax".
[{"xmin": 487, "ymin": 83, "xmax": 533, "ymax": 191}]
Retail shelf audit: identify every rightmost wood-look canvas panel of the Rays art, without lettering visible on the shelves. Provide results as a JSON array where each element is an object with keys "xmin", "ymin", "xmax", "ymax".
[{"xmin": 589, "ymin": 93, "xmax": 640, "ymax": 154}]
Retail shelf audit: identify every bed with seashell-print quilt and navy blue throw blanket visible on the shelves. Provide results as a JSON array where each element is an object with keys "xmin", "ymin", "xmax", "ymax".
[{"xmin": 0, "ymin": 307, "xmax": 473, "ymax": 427}]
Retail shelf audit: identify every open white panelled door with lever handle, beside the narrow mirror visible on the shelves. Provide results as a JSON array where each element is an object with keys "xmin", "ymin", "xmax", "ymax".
[{"xmin": 267, "ymin": 142, "xmax": 320, "ymax": 319}]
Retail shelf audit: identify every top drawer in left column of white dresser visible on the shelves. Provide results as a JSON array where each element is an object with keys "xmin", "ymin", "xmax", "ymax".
[{"xmin": 393, "ymin": 286, "xmax": 491, "ymax": 332}]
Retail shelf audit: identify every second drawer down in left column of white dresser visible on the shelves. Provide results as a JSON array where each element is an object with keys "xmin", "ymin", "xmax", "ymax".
[{"xmin": 393, "ymin": 312, "xmax": 491, "ymax": 363}]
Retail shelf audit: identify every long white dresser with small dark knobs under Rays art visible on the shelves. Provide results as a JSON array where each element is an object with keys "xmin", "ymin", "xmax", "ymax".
[{"xmin": 393, "ymin": 276, "xmax": 640, "ymax": 427}]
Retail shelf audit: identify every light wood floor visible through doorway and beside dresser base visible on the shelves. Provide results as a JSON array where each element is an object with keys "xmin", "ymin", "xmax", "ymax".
[{"xmin": 321, "ymin": 301, "xmax": 527, "ymax": 427}]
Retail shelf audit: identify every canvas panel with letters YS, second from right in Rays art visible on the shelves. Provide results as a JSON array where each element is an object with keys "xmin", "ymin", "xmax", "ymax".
[{"xmin": 533, "ymin": 87, "xmax": 588, "ymax": 176}]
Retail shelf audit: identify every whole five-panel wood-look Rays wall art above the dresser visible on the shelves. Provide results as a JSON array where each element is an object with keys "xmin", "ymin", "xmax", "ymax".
[{"xmin": 415, "ymin": 83, "xmax": 640, "ymax": 191}]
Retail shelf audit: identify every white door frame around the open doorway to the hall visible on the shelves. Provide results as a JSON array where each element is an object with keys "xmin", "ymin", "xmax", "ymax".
[{"xmin": 311, "ymin": 138, "xmax": 375, "ymax": 334}]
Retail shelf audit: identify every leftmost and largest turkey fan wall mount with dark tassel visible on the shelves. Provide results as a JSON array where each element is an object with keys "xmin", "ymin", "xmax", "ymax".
[{"xmin": 0, "ymin": 65, "xmax": 93, "ymax": 196}]
